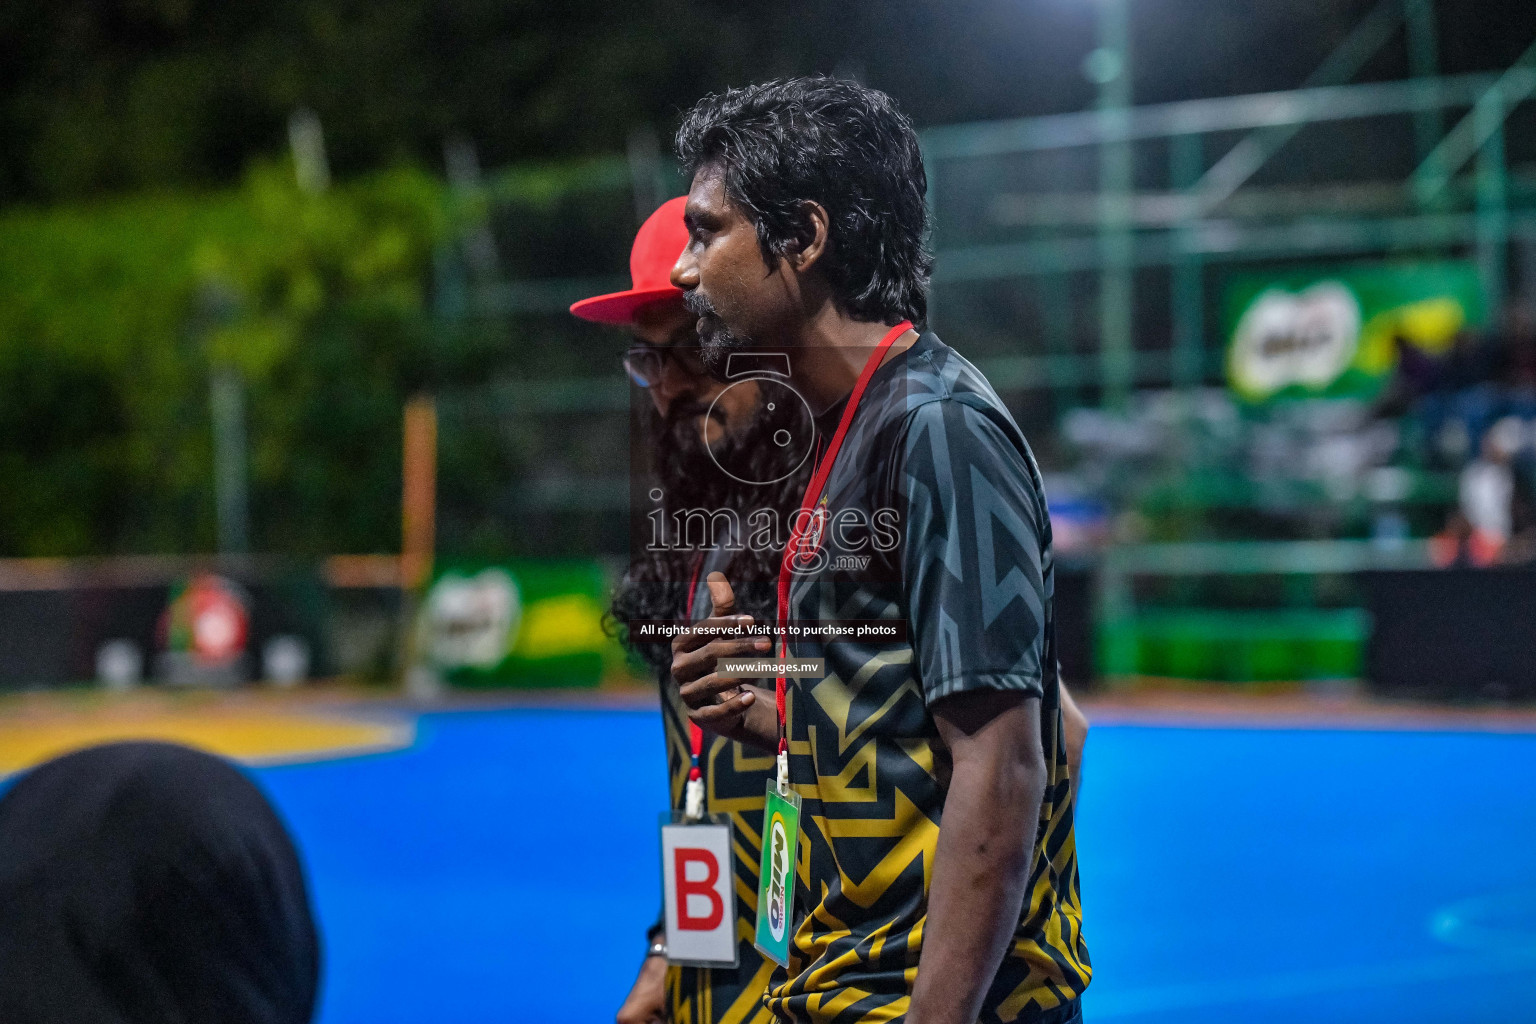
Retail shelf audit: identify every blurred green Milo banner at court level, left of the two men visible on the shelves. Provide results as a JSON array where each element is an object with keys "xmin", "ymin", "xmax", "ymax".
[{"xmin": 418, "ymin": 560, "xmax": 624, "ymax": 688}]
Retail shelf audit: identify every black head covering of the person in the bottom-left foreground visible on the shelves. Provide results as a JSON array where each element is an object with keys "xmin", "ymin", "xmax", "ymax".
[{"xmin": 0, "ymin": 743, "xmax": 319, "ymax": 1024}]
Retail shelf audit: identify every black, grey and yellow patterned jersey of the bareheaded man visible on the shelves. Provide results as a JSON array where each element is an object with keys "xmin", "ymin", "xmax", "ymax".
[{"xmin": 768, "ymin": 333, "xmax": 1091, "ymax": 1024}]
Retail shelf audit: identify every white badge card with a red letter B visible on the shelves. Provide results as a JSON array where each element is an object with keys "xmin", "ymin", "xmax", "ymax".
[{"xmin": 662, "ymin": 821, "xmax": 737, "ymax": 967}]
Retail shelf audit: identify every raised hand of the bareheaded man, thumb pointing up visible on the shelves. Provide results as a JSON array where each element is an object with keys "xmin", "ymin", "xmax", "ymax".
[{"xmin": 671, "ymin": 573, "xmax": 779, "ymax": 749}]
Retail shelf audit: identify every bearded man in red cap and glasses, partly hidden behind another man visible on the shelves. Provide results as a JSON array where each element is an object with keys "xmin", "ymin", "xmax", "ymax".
[{"xmin": 571, "ymin": 197, "xmax": 808, "ymax": 1024}]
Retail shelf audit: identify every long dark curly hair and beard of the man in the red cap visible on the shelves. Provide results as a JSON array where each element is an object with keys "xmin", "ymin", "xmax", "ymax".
[{"xmin": 610, "ymin": 388, "xmax": 813, "ymax": 669}]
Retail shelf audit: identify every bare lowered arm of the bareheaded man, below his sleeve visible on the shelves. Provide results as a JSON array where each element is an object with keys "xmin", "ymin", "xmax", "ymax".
[{"xmin": 906, "ymin": 705, "xmax": 1046, "ymax": 1024}]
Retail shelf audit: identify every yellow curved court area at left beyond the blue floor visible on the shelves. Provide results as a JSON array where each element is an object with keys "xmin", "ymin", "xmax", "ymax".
[{"xmin": 0, "ymin": 709, "xmax": 415, "ymax": 774}]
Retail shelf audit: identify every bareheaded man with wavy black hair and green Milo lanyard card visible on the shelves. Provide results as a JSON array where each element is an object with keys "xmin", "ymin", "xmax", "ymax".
[{"xmin": 671, "ymin": 78, "xmax": 1091, "ymax": 1024}]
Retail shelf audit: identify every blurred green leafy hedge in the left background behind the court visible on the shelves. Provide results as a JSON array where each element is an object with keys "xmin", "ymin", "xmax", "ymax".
[{"xmin": 0, "ymin": 164, "xmax": 447, "ymax": 556}]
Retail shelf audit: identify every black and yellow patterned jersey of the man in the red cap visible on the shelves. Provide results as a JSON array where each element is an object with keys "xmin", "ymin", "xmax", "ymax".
[{"xmin": 660, "ymin": 553, "xmax": 774, "ymax": 1024}]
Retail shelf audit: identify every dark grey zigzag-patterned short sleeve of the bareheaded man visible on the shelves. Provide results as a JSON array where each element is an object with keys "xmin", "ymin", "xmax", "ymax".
[{"xmin": 894, "ymin": 398, "xmax": 1049, "ymax": 705}]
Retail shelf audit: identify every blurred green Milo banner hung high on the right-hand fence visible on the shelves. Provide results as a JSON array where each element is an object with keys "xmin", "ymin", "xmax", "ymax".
[{"xmin": 1226, "ymin": 261, "xmax": 1484, "ymax": 402}]
